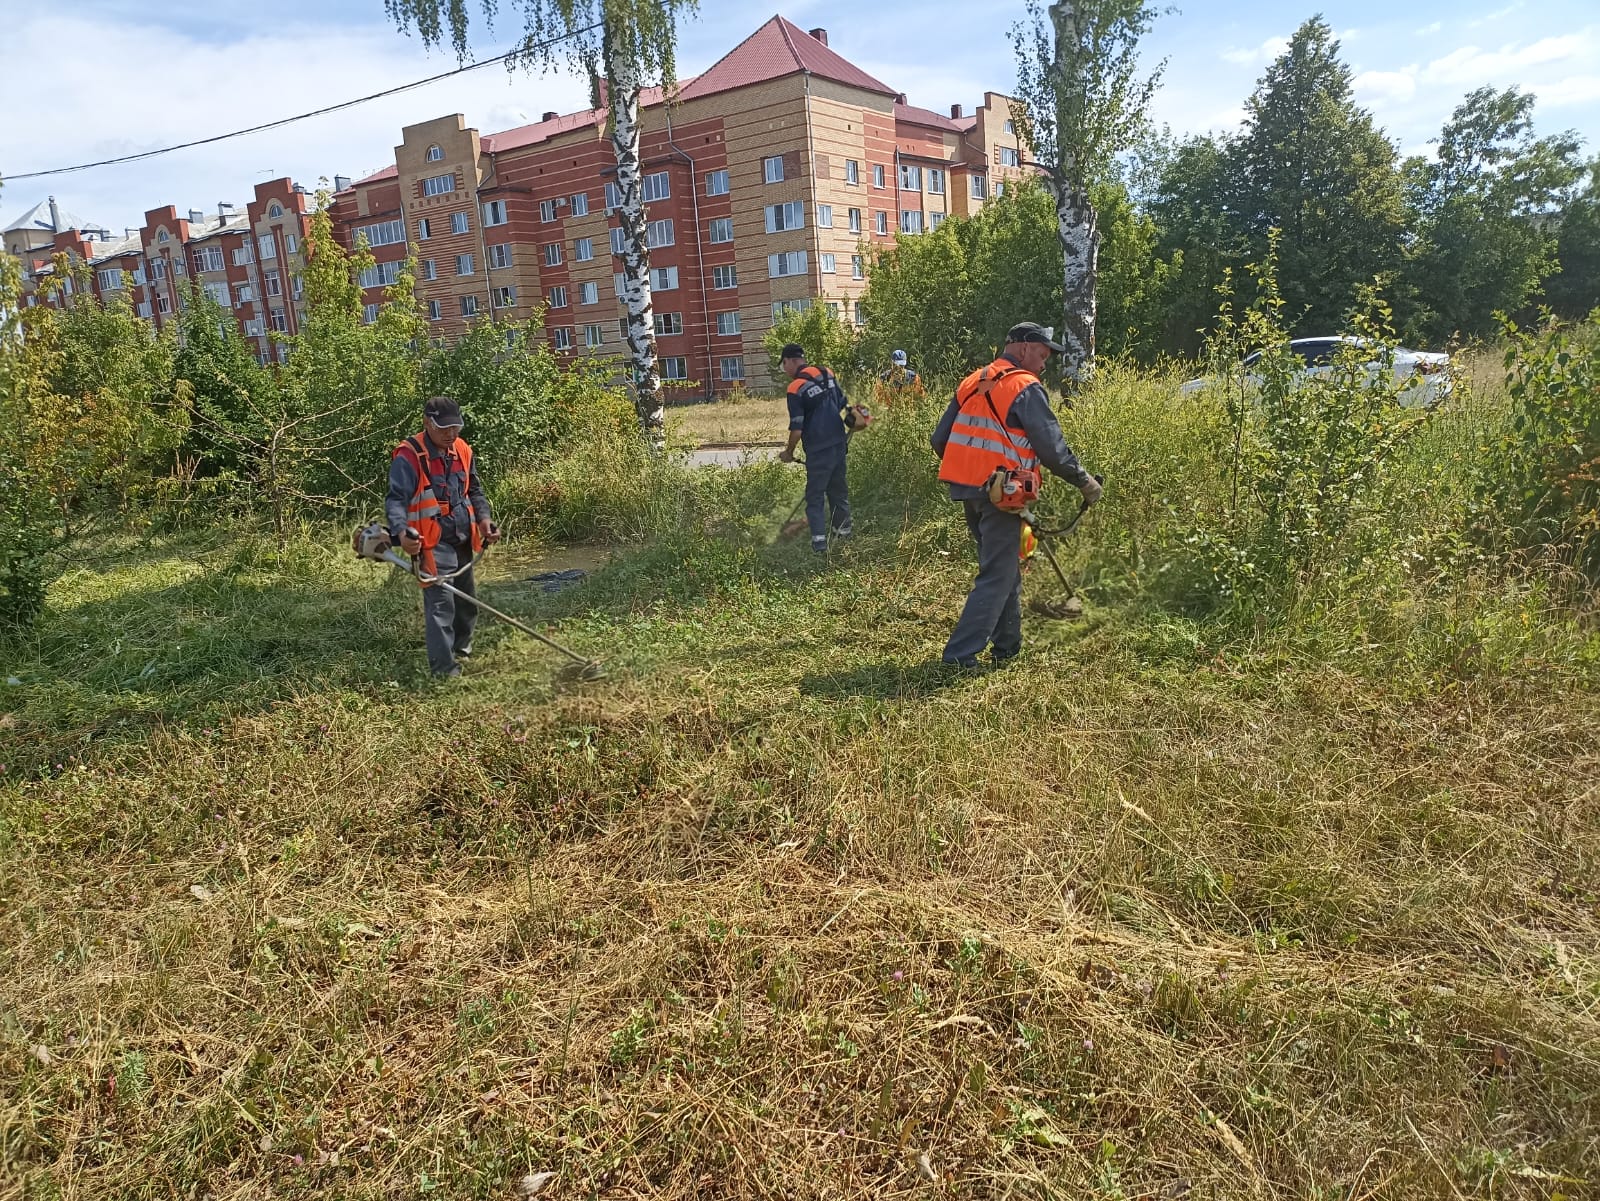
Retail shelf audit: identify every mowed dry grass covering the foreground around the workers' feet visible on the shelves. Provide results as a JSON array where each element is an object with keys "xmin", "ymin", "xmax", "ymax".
[{"xmin": 0, "ymin": 508, "xmax": 1600, "ymax": 1198}]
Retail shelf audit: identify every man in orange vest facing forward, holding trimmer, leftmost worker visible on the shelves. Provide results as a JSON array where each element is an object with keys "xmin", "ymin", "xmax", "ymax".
[{"xmin": 384, "ymin": 397, "xmax": 499, "ymax": 678}]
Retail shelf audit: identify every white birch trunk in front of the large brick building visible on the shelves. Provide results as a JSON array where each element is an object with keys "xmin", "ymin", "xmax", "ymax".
[{"xmin": 602, "ymin": 27, "xmax": 667, "ymax": 448}]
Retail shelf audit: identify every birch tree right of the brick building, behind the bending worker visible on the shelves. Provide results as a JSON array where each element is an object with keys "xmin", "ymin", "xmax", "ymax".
[{"xmin": 1011, "ymin": 0, "xmax": 1165, "ymax": 384}]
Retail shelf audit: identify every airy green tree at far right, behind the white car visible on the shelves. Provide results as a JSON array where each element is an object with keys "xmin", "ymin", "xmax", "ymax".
[{"xmin": 1406, "ymin": 88, "xmax": 1581, "ymax": 337}]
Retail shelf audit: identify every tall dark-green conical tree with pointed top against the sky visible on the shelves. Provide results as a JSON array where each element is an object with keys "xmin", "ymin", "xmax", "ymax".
[{"xmin": 1222, "ymin": 18, "xmax": 1406, "ymax": 333}]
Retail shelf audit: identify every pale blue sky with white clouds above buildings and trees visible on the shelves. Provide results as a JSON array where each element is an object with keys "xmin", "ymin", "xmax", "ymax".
[{"xmin": 0, "ymin": 0, "xmax": 1600, "ymax": 235}]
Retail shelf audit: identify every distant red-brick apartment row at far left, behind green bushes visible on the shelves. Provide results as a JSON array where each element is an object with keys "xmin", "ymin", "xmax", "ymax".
[{"xmin": 5, "ymin": 178, "xmax": 310, "ymax": 363}]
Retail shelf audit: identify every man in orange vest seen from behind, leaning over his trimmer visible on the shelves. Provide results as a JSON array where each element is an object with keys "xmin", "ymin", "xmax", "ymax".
[{"xmin": 933, "ymin": 321, "xmax": 1101, "ymax": 668}]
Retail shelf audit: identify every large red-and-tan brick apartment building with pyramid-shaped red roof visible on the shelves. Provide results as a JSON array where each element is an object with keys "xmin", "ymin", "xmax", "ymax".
[{"xmin": 331, "ymin": 18, "xmax": 1024, "ymax": 392}]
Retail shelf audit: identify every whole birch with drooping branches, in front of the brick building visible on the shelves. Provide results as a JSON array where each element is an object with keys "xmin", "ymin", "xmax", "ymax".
[{"xmin": 384, "ymin": 0, "xmax": 698, "ymax": 445}]
